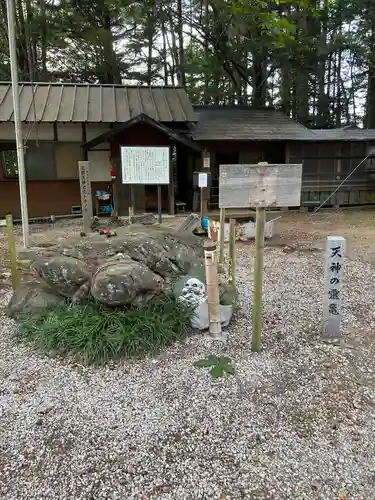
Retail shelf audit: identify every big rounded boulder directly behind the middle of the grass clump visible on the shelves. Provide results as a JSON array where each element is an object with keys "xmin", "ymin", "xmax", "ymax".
[{"xmin": 91, "ymin": 257, "xmax": 164, "ymax": 307}]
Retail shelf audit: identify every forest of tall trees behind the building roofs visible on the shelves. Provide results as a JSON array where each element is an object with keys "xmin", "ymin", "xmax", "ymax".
[{"xmin": 0, "ymin": 0, "xmax": 375, "ymax": 128}]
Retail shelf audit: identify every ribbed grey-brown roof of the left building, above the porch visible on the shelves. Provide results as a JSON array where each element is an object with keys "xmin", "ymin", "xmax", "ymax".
[{"xmin": 0, "ymin": 83, "xmax": 196, "ymax": 123}]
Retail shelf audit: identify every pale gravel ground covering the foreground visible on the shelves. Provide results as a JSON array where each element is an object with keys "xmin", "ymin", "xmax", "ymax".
[{"xmin": 0, "ymin": 240, "xmax": 375, "ymax": 500}]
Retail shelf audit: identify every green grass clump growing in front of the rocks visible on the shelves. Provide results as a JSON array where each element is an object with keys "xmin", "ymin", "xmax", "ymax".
[{"xmin": 18, "ymin": 297, "xmax": 193, "ymax": 364}]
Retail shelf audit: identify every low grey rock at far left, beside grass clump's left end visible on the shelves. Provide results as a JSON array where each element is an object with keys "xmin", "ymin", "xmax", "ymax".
[{"xmin": 7, "ymin": 282, "xmax": 65, "ymax": 319}]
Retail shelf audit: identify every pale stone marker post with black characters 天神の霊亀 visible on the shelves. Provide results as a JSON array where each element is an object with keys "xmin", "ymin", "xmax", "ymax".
[{"xmin": 323, "ymin": 236, "xmax": 345, "ymax": 340}]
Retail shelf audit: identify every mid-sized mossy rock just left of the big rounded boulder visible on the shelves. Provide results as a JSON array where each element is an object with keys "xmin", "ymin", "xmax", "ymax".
[{"xmin": 33, "ymin": 255, "xmax": 90, "ymax": 297}]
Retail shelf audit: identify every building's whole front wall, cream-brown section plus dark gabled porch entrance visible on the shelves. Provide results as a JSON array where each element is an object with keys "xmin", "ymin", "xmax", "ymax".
[{"xmin": 0, "ymin": 123, "xmax": 194, "ymax": 217}]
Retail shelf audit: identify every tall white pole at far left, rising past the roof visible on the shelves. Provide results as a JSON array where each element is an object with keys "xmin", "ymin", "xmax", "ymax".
[{"xmin": 7, "ymin": 0, "xmax": 29, "ymax": 248}]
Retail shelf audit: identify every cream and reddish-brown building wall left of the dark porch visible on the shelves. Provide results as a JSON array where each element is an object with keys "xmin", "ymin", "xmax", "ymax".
[{"xmin": 0, "ymin": 123, "xmax": 111, "ymax": 217}]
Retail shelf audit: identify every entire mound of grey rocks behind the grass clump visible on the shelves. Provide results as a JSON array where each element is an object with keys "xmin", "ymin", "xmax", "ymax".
[{"xmin": 9, "ymin": 224, "xmax": 204, "ymax": 314}]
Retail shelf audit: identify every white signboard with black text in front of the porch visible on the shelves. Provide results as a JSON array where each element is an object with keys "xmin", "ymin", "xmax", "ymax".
[{"xmin": 121, "ymin": 146, "xmax": 170, "ymax": 184}]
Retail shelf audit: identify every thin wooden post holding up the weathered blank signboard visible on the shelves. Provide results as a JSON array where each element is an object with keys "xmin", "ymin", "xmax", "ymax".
[{"xmin": 252, "ymin": 207, "xmax": 266, "ymax": 352}]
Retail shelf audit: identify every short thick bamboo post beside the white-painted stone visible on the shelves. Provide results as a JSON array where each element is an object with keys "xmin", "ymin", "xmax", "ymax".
[{"xmin": 204, "ymin": 241, "xmax": 221, "ymax": 338}]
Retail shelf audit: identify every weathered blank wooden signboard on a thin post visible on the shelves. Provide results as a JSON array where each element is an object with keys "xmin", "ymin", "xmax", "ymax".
[{"xmin": 219, "ymin": 163, "xmax": 302, "ymax": 208}]
